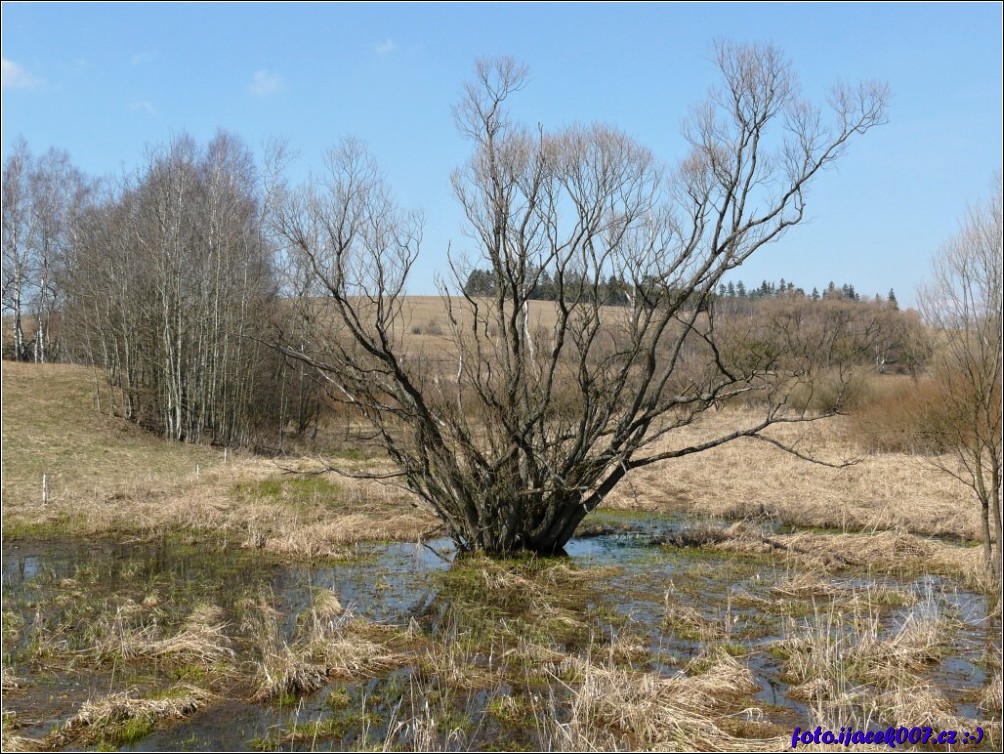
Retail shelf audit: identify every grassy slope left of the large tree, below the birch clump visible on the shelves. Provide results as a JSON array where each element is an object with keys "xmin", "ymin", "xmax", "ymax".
[{"xmin": 3, "ymin": 361, "xmax": 434, "ymax": 556}]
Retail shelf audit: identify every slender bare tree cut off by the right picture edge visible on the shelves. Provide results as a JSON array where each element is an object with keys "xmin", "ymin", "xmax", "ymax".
[{"xmin": 920, "ymin": 173, "xmax": 1004, "ymax": 579}]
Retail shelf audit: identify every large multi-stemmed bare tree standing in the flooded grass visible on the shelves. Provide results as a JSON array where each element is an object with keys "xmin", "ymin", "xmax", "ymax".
[{"xmin": 281, "ymin": 43, "xmax": 886, "ymax": 553}]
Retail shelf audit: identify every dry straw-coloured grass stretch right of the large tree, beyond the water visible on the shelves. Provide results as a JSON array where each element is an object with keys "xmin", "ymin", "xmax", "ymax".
[{"xmin": 604, "ymin": 410, "xmax": 979, "ymax": 539}]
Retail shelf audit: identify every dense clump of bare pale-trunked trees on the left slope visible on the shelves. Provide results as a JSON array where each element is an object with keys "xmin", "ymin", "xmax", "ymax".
[{"xmin": 66, "ymin": 132, "xmax": 282, "ymax": 445}]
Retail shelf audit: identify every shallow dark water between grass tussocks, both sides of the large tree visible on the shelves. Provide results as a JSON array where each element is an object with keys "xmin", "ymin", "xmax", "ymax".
[{"xmin": 3, "ymin": 516, "xmax": 999, "ymax": 751}]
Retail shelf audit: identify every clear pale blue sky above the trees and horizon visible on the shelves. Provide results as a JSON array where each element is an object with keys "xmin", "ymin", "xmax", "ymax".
[{"xmin": 0, "ymin": 3, "xmax": 1004, "ymax": 303}]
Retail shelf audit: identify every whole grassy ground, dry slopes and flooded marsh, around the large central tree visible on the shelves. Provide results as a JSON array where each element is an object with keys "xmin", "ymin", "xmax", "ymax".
[{"xmin": 2, "ymin": 357, "xmax": 1001, "ymax": 751}]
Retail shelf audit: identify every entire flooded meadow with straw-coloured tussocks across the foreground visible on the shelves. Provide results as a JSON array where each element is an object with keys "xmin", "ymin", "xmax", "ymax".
[{"xmin": 3, "ymin": 511, "xmax": 1001, "ymax": 751}]
